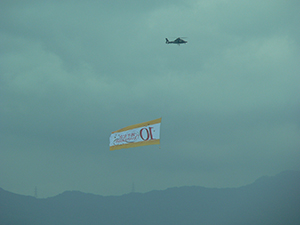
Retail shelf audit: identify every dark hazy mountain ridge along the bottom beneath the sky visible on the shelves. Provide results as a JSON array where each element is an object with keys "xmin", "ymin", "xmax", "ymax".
[{"xmin": 0, "ymin": 171, "xmax": 300, "ymax": 225}]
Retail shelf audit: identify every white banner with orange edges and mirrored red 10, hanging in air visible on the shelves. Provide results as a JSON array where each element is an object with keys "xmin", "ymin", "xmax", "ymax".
[{"xmin": 109, "ymin": 118, "xmax": 161, "ymax": 151}]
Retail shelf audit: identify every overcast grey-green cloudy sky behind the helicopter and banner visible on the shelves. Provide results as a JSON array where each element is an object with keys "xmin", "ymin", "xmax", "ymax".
[{"xmin": 0, "ymin": 0, "xmax": 300, "ymax": 198}]
